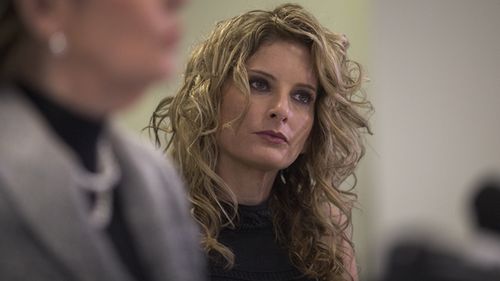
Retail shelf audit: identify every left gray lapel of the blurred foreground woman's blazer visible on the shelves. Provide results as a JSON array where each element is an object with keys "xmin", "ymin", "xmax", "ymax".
[{"xmin": 0, "ymin": 88, "xmax": 130, "ymax": 281}]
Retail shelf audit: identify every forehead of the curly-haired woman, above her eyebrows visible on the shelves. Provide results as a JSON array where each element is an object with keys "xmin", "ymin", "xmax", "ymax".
[{"xmin": 247, "ymin": 40, "xmax": 317, "ymax": 85}]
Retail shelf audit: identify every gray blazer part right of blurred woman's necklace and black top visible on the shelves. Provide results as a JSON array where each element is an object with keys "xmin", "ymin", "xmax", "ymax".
[{"xmin": 110, "ymin": 127, "xmax": 203, "ymax": 281}]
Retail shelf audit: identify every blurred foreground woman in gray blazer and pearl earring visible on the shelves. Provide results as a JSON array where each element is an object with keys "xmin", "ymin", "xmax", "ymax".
[{"xmin": 0, "ymin": 0, "xmax": 204, "ymax": 281}]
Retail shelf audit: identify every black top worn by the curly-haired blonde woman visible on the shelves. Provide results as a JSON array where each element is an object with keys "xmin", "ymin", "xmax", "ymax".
[{"xmin": 209, "ymin": 202, "xmax": 312, "ymax": 281}]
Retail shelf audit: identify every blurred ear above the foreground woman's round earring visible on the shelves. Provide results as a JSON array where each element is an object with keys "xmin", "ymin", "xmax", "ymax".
[{"xmin": 14, "ymin": 0, "xmax": 72, "ymax": 41}]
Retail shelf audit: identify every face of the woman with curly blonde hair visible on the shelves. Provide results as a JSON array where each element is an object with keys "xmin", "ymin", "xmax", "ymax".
[{"xmin": 217, "ymin": 41, "xmax": 318, "ymax": 171}]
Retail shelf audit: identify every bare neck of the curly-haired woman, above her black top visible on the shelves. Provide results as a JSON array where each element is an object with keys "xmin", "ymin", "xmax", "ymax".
[{"xmin": 216, "ymin": 156, "xmax": 278, "ymax": 205}]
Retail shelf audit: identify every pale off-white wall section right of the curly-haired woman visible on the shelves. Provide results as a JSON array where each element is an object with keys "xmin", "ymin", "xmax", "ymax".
[{"xmin": 369, "ymin": 0, "xmax": 500, "ymax": 276}]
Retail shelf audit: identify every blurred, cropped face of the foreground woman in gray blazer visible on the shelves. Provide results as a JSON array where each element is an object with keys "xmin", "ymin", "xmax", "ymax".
[{"xmin": 63, "ymin": 0, "xmax": 185, "ymax": 89}]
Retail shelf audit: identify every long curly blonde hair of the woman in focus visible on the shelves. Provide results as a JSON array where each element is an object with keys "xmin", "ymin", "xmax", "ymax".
[{"xmin": 149, "ymin": 4, "xmax": 372, "ymax": 280}]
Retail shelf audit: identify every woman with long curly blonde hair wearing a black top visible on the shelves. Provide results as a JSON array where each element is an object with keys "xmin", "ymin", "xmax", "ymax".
[{"xmin": 150, "ymin": 4, "xmax": 371, "ymax": 281}]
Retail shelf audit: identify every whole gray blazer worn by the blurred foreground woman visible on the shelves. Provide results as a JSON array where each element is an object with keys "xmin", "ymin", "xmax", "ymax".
[{"xmin": 0, "ymin": 88, "xmax": 205, "ymax": 281}]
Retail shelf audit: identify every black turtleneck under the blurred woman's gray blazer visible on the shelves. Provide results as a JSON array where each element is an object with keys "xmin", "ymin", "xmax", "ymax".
[{"xmin": 17, "ymin": 83, "xmax": 151, "ymax": 281}]
